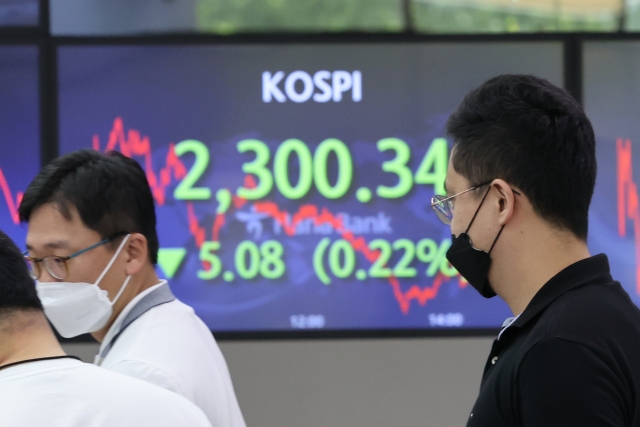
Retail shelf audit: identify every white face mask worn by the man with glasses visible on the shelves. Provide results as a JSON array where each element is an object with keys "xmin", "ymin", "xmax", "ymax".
[{"xmin": 36, "ymin": 234, "xmax": 131, "ymax": 338}]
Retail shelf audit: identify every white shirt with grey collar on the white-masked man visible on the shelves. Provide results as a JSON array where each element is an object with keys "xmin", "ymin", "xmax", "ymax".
[{"xmin": 96, "ymin": 281, "xmax": 246, "ymax": 427}]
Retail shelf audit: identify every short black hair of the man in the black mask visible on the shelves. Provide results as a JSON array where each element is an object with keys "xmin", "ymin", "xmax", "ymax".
[{"xmin": 446, "ymin": 74, "xmax": 597, "ymax": 241}]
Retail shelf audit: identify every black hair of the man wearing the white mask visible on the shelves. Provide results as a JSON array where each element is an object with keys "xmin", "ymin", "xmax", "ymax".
[{"xmin": 18, "ymin": 149, "xmax": 158, "ymax": 265}]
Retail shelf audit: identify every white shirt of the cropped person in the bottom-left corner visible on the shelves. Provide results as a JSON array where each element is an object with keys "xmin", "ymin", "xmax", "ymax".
[{"xmin": 0, "ymin": 359, "xmax": 211, "ymax": 427}]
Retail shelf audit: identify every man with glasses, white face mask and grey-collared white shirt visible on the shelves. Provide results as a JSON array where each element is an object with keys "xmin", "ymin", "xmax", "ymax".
[{"xmin": 19, "ymin": 150, "xmax": 245, "ymax": 427}]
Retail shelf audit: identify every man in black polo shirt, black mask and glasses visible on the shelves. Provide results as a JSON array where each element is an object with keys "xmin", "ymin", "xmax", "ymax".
[{"xmin": 432, "ymin": 75, "xmax": 640, "ymax": 427}]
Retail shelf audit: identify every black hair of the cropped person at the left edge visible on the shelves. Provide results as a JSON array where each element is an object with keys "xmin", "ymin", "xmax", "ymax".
[{"xmin": 0, "ymin": 230, "xmax": 43, "ymax": 315}]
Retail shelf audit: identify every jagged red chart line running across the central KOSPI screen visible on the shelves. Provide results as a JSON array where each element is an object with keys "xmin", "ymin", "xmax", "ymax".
[{"xmin": 95, "ymin": 117, "xmax": 466, "ymax": 315}]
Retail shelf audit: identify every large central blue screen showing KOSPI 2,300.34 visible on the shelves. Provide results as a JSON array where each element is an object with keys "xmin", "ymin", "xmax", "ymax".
[{"xmin": 57, "ymin": 42, "xmax": 563, "ymax": 332}]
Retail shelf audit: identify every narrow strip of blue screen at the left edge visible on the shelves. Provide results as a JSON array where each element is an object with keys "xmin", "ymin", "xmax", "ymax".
[{"xmin": 0, "ymin": 45, "xmax": 40, "ymax": 254}]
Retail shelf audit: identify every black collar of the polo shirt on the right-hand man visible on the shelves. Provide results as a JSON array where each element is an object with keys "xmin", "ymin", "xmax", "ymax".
[{"xmin": 510, "ymin": 254, "xmax": 613, "ymax": 327}]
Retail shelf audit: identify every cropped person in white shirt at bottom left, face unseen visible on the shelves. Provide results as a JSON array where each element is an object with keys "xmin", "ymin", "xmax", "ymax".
[{"xmin": 0, "ymin": 231, "xmax": 211, "ymax": 427}]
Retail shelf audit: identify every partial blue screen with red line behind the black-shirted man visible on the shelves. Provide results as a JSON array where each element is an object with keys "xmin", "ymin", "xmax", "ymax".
[{"xmin": 584, "ymin": 41, "xmax": 640, "ymax": 312}]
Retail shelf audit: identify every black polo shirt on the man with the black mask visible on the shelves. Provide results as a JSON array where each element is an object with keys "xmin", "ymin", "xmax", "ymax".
[{"xmin": 467, "ymin": 254, "xmax": 640, "ymax": 427}]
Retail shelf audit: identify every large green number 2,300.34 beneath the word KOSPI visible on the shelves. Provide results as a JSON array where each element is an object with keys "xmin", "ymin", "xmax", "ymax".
[{"xmin": 174, "ymin": 138, "xmax": 448, "ymax": 204}]
